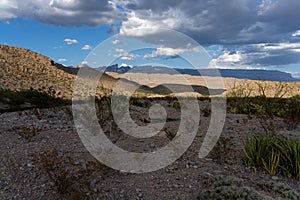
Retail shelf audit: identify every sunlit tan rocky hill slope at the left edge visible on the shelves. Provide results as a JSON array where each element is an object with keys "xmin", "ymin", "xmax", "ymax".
[{"xmin": 0, "ymin": 45, "xmax": 75, "ymax": 99}]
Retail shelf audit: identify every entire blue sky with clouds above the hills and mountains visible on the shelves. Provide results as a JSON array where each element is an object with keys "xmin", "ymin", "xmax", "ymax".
[{"xmin": 0, "ymin": 0, "xmax": 300, "ymax": 77}]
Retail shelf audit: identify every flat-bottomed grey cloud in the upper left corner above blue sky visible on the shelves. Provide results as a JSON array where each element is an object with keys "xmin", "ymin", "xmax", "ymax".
[{"xmin": 0, "ymin": 0, "xmax": 124, "ymax": 26}]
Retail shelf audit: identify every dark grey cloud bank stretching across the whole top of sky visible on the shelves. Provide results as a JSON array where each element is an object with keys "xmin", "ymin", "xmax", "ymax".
[{"xmin": 0, "ymin": 0, "xmax": 300, "ymax": 66}]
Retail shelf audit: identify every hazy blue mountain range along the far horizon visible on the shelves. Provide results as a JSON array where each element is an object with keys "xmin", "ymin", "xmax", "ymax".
[{"xmin": 98, "ymin": 65, "xmax": 300, "ymax": 82}]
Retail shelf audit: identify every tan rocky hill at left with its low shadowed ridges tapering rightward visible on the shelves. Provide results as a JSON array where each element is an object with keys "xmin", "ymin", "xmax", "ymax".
[{"xmin": 0, "ymin": 44, "xmax": 224, "ymax": 98}]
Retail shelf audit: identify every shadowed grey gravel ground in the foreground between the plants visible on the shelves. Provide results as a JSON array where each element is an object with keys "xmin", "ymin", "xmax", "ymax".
[{"xmin": 0, "ymin": 101, "xmax": 300, "ymax": 199}]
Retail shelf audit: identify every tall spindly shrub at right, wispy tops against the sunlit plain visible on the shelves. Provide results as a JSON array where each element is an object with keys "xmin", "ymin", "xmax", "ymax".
[{"xmin": 228, "ymin": 81, "xmax": 292, "ymax": 134}]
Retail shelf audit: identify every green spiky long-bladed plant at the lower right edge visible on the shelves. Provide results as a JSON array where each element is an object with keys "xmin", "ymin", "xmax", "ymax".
[{"xmin": 244, "ymin": 135, "xmax": 300, "ymax": 181}]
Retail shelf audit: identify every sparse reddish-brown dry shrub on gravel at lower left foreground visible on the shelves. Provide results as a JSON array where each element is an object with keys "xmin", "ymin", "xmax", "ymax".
[{"xmin": 33, "ymin": 148, "xmax": 104, "ymax": 199}]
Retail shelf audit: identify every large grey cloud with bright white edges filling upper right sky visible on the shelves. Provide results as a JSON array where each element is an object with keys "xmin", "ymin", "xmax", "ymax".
[{"xmin": 119, "ymin": 0, "xmax": 300, "ymax": 68}]
